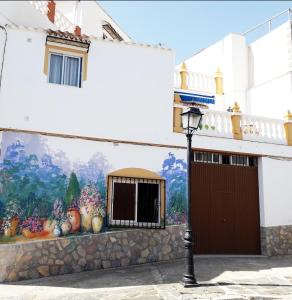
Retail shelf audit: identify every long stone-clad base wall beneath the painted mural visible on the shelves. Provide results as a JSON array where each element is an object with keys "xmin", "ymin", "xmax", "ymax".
[{"xmin": 0, "ymin": 225, "xmax": 185, "ymax": 282}]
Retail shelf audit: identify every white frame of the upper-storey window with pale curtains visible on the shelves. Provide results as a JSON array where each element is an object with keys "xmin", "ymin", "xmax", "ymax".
[{"xmin": 47, "ymin": 51, "xmax": 83, "ymax": 88}]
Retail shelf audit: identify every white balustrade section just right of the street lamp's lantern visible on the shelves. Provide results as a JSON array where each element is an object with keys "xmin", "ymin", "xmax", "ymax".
[{"xmin": 195, "ymin": 109, "xmax": 233, "ymax": 138}]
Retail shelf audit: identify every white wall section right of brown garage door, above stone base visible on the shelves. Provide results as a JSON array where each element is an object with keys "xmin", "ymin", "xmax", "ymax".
[{"xmin": 259, "ymin": 157, "xmax": 292, "ymax": 227}]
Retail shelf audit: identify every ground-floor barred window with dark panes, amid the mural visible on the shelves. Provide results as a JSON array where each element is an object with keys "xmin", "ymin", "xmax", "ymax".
[{"xmin": 108, "ymin": 169, "xmax": 165, "ymax": 228}]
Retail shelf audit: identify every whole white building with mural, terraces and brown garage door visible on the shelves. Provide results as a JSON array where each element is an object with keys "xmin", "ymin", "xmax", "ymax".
[{"xmin": 0, "ymin": 1, "xmax": 292, "ymax": 281}]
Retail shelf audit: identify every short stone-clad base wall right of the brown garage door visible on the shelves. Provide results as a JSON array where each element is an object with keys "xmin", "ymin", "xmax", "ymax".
[{"xmin": 261, "ymin": 225, "xmax": 292, "ymax": 256}]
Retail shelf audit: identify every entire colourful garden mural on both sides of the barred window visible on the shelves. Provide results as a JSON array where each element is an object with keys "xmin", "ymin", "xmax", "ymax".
[{"xmin": 0, "ymin": 132, "xmax": 186, "ymax": 243}]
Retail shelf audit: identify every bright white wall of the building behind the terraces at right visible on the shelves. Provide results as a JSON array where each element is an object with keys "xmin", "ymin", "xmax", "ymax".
[{"xmin": 182, "ymin": 22, "xmax": 292, "ymax": 118}]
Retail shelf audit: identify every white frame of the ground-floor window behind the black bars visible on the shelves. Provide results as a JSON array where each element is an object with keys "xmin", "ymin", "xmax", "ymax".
[{"xmin": 109, "ymin": 178, "xmax": 161, "ymax": 227}]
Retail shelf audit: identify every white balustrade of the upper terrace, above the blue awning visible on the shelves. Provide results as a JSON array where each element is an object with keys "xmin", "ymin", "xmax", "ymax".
[{"xmin": 174, "ymin": 70, "xmax": 215, "ymax": 93}]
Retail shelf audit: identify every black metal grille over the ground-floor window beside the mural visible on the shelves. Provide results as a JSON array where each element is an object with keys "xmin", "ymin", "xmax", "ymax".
[{"xmin": 107, "ymin": 176, "xmax": 165, "ymax": 229}]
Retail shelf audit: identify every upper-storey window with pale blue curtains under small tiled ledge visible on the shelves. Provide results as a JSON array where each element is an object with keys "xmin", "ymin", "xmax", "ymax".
[{"xmin": 49, "ymin": 53, "xmax": 82, "ymax": 87}]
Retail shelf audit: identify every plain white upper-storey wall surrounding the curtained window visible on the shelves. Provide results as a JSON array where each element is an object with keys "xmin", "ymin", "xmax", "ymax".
[{"xmin": 0, "ymin": 29, "xmax": 174, "ymax": 142}]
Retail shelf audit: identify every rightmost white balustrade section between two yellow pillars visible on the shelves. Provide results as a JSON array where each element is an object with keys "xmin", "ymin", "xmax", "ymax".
[{"xmin": 241, "ymin": 115, "xmax": 286, "ymax": 144}]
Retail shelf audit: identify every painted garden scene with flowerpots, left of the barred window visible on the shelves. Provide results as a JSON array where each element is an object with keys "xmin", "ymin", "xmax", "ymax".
[{"xmin": 0, "ymin": 136, "xmax": 107, "ymax": 243}]
